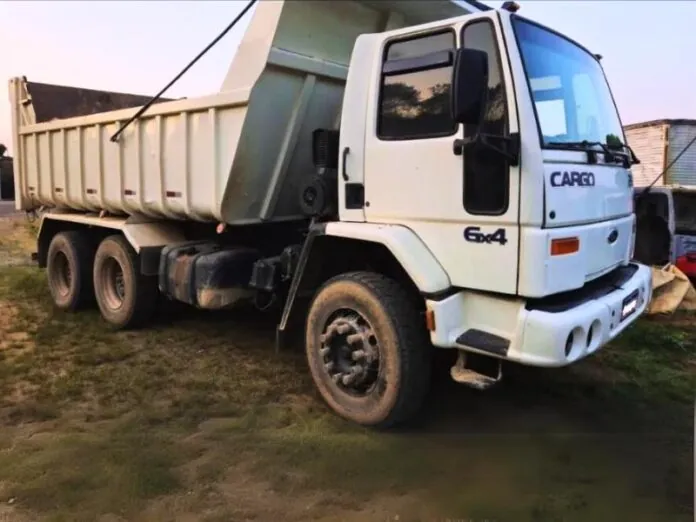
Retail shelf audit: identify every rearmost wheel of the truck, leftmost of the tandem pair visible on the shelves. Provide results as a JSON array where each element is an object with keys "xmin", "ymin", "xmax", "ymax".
[{"xmin": 46, "ymin": 230, "xmax": 94, "ymax": 312}]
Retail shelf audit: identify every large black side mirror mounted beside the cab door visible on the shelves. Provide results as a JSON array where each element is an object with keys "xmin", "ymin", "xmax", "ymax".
[{"xmin": 451, "ymin": 49, "xmax": 488, "ymax": 125}]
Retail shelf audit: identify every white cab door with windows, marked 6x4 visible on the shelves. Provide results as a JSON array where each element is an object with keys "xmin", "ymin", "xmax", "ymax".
[{"xmin": 365, "ymin": 14, "xmax": 519, "ymax": 294}]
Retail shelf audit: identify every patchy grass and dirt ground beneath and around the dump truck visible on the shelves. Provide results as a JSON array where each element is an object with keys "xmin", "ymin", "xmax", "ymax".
[{"xmin": 0, "ymin": 256, "xmax": 696, "ymax": 522}]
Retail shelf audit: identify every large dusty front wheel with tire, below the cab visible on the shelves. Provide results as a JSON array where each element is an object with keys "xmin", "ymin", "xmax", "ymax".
[{"xmin": 305, "ymin": 272, "xmax": 432, "ymax": 428}]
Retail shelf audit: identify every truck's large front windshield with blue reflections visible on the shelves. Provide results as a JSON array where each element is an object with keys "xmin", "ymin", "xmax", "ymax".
[{"xmin": 513, "ymin": 17, "xmax": 625, "ymax": 148}]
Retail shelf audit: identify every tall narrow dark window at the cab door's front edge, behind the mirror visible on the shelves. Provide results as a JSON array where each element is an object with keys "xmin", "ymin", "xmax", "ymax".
[{"xmin": 462, "ymin": 20, "xmax": 510, "ymax": 215}]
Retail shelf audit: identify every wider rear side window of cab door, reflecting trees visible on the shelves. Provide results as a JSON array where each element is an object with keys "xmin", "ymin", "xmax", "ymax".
[{"xmin": 377, "ymin": 31, "xmax": 457, "ymax": 140}]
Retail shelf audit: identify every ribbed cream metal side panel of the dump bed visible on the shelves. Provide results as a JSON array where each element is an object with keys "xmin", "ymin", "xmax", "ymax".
[{"xmin": 10, "ymin": 78, "xmax": 249, "ymax": 221}]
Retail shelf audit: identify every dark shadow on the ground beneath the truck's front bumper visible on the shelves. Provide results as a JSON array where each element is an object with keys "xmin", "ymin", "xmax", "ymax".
[{"xmin": 421, "ymin": 352, "xmax": 675, "ymax": 435}]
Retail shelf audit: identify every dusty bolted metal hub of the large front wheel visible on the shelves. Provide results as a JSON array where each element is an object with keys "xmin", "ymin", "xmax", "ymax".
[{"xmin": 320, "ymin": 312, "xmax": 380, "ymax": 395}]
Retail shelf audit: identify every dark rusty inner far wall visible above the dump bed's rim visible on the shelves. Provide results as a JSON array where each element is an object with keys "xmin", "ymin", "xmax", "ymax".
[{"xmin": 25, "ymin": 79, "xmax": 177, "ymax": 123}]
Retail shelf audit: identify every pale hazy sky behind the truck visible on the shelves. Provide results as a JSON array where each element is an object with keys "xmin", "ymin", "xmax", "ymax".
[{"xmin": 0, "ymin": 0, "xmax": 696, "ymax": 154}]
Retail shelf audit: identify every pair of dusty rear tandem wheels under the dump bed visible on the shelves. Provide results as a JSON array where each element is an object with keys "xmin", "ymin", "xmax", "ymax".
[{"xmin": 46, "ymin": 230, "xmax": 158, "ymax": 329}]
